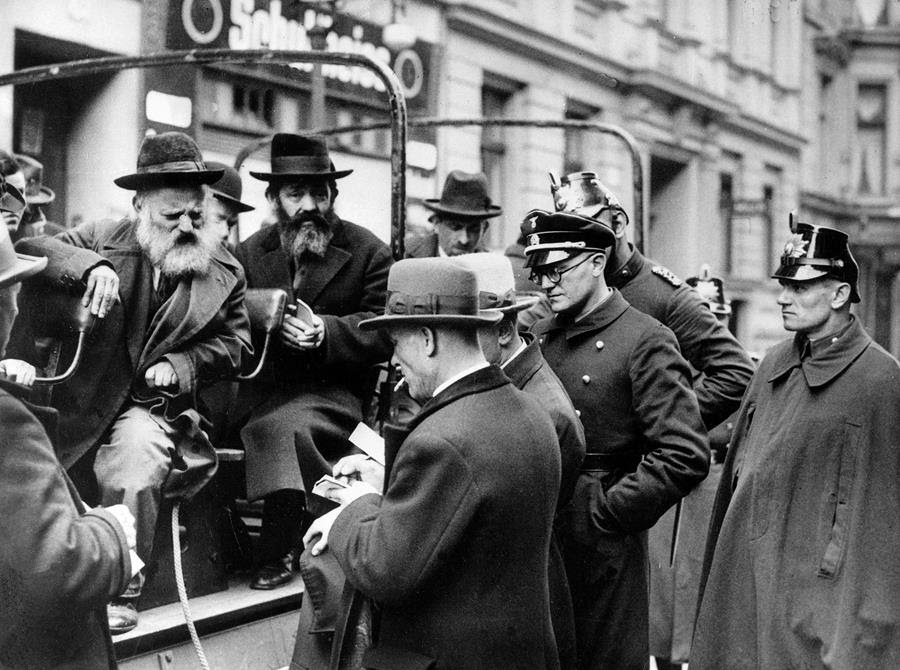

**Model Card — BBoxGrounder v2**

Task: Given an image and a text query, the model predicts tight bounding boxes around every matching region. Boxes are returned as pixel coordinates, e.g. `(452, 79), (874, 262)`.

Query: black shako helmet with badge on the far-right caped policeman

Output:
(772, 217), (859, 302)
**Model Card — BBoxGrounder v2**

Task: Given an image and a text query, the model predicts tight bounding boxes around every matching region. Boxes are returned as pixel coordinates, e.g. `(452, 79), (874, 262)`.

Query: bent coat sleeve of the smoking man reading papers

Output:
(328, 435), (479, 603)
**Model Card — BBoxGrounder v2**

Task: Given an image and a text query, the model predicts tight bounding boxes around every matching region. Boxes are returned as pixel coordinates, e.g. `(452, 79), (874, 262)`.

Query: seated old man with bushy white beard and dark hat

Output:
(4, 132), (250, 633)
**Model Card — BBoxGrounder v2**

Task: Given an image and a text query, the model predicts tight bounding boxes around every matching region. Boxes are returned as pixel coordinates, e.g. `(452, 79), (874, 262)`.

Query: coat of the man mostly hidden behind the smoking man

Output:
(503, 334), (585, 670)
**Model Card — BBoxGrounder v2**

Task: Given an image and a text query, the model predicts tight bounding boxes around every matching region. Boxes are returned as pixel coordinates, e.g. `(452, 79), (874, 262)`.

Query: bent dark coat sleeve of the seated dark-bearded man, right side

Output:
(320, 245), (394, 368)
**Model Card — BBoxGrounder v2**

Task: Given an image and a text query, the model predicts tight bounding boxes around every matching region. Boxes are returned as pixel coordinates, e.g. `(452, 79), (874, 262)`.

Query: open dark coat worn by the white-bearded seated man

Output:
(14, 219), (251, 476)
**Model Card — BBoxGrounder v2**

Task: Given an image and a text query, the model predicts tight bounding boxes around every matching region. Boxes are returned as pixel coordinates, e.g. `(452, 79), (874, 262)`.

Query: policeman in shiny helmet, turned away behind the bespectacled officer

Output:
(551, 172), (753, 428)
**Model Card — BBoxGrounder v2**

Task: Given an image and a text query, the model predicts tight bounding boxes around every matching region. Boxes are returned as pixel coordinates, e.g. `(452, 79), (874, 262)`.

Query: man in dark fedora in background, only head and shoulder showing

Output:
(406, 170), (503, 258)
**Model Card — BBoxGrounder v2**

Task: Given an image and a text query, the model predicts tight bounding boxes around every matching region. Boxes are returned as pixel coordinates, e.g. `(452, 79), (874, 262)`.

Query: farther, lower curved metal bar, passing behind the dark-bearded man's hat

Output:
(235, 117), (650, 254)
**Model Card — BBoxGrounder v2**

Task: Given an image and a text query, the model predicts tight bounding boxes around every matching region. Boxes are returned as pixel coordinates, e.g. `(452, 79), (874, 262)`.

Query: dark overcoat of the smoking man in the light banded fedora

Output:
(329, 366), (560, 670)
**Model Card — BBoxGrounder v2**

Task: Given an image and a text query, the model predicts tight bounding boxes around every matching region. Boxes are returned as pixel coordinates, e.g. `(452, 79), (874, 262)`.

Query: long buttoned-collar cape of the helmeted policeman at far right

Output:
(691, 320), (900, 670)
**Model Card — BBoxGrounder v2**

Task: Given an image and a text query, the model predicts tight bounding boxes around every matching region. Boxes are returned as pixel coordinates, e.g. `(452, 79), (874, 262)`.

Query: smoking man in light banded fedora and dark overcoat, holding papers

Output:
(305, 258), (560, 668)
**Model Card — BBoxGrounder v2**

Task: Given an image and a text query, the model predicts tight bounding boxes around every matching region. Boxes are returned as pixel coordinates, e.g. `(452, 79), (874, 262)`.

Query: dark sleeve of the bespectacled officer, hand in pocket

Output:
(597, 324), (709, 533)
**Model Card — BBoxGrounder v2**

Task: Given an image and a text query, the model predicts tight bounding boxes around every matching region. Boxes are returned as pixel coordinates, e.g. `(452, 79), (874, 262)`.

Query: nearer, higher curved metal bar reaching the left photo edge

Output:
(0, 49), (407, 259)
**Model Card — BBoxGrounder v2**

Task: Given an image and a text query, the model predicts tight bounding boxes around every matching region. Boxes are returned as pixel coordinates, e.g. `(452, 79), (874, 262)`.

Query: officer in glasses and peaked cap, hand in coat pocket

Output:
(522, 208), (709, 670)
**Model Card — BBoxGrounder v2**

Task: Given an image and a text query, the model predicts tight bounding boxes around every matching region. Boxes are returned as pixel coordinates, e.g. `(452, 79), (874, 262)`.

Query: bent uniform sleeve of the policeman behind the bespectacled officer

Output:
(665, 287), (753, 428)
